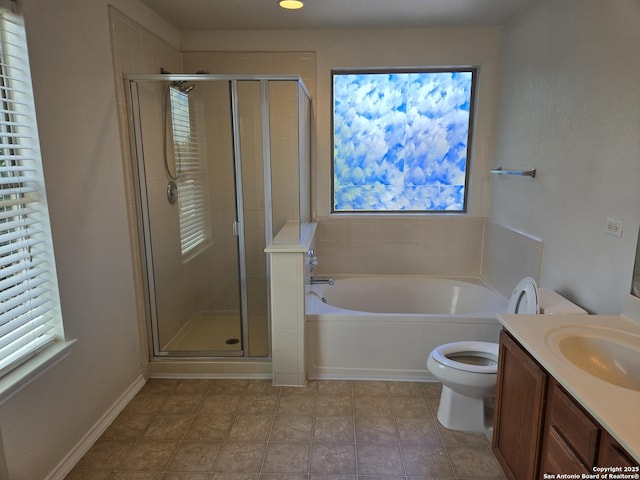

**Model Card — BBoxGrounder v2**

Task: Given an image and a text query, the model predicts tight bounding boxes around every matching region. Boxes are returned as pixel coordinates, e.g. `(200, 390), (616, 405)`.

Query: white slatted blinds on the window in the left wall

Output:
(0, 9), (64, 377)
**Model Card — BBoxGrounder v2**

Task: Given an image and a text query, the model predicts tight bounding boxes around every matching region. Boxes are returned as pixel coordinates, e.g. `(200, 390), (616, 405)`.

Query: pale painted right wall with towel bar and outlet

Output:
(491, 0), (640, 314)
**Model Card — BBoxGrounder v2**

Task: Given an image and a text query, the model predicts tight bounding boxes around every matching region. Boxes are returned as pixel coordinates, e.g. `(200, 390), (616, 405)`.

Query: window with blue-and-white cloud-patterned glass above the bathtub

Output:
(332, 69), (476, 213)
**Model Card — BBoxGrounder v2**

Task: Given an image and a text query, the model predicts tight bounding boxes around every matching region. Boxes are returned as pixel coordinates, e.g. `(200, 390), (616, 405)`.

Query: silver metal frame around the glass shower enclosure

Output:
(124, 74), (310, 361)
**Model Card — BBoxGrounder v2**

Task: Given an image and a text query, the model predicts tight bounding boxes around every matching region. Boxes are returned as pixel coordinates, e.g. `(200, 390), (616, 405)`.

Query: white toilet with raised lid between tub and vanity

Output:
(427, 277), (587, 434)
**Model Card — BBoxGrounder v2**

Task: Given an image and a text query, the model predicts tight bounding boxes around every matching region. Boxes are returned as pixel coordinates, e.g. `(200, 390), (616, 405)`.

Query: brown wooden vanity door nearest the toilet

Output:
(493, 331), (547, 480)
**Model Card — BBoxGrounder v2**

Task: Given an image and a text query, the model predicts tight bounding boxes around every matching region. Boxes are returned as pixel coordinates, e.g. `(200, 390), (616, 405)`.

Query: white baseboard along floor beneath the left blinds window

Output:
(45, 375), (146, 480)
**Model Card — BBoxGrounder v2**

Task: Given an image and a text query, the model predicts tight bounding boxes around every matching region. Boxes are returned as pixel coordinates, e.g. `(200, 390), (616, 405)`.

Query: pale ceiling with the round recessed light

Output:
(141, 0), (535, 30)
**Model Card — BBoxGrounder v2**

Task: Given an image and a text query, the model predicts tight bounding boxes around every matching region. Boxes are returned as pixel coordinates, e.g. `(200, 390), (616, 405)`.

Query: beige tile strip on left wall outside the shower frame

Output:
(109, 7), (182, 363)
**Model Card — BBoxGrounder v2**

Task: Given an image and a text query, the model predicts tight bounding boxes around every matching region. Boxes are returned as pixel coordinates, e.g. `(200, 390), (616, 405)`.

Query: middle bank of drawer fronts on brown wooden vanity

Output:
(540, 380), (600, 474)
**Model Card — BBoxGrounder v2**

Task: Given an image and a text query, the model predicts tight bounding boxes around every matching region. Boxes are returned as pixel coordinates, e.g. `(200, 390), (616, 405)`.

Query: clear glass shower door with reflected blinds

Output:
(131, 81), (244, 357)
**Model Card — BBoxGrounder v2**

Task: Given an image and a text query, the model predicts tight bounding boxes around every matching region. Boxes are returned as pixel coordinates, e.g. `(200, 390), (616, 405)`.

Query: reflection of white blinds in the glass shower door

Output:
(169, 87), (209, 258)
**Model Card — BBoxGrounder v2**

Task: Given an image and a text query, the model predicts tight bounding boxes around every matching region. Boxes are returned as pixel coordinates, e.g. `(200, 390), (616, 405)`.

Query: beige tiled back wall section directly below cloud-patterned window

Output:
(316, 216), (485, 276)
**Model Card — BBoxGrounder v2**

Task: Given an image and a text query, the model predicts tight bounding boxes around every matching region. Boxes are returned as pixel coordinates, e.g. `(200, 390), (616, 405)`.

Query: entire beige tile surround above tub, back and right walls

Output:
(316, 215), (543, 298)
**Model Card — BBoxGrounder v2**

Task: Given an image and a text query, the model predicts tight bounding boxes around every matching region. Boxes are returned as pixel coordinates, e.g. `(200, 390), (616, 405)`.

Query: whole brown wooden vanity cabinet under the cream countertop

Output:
(493, 330), (638, 480)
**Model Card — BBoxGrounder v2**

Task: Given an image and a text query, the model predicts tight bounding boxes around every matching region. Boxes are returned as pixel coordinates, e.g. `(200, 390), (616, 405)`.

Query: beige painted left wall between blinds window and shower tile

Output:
(0, 0), (178, 480)
